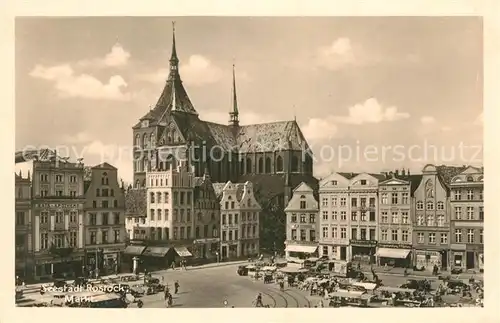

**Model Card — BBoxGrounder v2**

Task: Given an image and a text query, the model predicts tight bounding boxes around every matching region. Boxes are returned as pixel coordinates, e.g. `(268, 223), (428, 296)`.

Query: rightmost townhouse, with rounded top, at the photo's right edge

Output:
(449, 167), (484, 270)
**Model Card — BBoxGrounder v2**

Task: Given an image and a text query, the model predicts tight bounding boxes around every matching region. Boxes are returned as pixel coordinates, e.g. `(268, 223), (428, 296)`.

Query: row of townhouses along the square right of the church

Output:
(285, 165), (484, 270)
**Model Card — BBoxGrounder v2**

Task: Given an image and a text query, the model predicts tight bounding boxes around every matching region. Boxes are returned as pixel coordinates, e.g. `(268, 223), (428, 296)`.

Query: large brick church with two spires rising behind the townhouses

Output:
(132, 27), (317, 206)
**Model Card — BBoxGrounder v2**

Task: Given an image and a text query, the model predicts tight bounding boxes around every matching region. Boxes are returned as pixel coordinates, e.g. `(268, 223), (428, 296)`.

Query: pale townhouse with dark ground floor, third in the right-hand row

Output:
(347, 173), (384, 263)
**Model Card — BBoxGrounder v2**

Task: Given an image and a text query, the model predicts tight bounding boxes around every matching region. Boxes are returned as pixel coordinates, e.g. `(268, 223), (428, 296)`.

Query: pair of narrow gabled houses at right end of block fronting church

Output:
(214, 181), (261, 259)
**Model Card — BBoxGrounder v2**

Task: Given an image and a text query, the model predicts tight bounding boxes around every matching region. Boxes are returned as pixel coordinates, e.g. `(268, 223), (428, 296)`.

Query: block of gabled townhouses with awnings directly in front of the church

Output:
(124, 161), (261, 269)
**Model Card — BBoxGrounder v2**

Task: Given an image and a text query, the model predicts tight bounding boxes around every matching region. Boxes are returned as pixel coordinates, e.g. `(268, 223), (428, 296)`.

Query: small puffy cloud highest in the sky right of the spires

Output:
(317, 37), (357, 70)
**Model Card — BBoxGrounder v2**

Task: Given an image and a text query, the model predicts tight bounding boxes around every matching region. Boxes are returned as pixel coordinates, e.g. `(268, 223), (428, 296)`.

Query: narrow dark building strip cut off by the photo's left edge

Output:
(15, 172), (33, 279)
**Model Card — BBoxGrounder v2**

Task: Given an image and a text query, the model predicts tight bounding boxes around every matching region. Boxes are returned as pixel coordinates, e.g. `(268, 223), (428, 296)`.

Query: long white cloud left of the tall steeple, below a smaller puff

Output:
(30, 64), (130, 101)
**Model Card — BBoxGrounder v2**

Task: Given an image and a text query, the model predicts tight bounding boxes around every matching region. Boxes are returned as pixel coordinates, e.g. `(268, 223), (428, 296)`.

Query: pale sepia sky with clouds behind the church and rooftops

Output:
(15, 17), (483, 182)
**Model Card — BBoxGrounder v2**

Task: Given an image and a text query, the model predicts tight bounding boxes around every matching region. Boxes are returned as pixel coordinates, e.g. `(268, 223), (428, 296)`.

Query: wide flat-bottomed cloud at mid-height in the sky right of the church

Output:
(332, 98), (410, 125)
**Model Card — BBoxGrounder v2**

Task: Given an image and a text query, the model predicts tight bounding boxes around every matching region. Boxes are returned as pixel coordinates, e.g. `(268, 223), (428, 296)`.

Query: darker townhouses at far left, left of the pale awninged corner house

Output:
(15, 156), (125, 280)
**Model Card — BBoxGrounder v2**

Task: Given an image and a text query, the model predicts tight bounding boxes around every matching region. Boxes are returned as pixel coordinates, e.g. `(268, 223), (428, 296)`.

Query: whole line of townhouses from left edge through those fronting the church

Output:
(15, 156), (261, 280)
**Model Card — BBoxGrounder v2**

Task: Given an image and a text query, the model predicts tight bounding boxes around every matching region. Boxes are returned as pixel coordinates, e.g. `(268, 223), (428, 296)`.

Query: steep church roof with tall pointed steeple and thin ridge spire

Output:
(134, 22), (310, 153)
